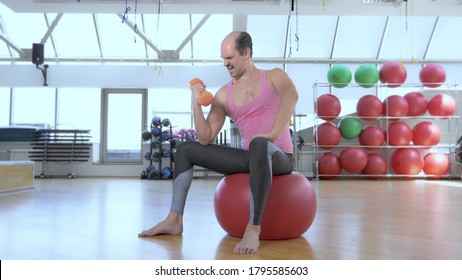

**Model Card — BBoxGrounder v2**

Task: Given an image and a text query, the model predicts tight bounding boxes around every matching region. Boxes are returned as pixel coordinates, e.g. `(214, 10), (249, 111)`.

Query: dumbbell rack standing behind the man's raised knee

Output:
(141, 117), (174, 180)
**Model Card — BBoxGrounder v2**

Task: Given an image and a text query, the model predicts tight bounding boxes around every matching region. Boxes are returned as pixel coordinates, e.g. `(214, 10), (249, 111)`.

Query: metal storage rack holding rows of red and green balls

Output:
(312, 82), (462, 179)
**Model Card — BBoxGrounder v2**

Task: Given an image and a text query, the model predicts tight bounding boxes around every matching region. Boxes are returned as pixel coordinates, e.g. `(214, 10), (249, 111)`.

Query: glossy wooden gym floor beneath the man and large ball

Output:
(0, 175), (462, 260)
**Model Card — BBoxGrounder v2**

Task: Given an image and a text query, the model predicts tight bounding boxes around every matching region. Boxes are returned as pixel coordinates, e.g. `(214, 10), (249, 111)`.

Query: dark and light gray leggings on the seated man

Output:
(170, 137), (293, 225)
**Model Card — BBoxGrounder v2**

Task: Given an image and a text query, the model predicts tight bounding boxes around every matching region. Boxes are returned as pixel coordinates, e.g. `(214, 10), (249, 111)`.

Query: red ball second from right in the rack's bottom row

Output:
(391, 148), (423, 175)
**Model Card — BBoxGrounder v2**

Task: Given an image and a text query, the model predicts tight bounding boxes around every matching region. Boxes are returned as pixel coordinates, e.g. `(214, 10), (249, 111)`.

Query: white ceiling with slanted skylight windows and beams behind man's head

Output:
(0, 0), (462, 63)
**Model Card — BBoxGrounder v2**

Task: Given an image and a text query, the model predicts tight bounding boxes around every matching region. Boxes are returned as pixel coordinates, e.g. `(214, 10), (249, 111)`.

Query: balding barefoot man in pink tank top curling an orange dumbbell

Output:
(139, 31), (298, 254)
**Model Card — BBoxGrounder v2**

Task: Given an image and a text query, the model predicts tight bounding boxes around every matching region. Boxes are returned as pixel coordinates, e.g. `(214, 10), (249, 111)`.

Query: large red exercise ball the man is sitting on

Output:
(214, 172), (317, 240)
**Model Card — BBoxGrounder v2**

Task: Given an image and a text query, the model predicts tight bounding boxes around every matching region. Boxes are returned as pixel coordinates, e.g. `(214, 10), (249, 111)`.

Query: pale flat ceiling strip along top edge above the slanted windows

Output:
(0, 0), (462, 16)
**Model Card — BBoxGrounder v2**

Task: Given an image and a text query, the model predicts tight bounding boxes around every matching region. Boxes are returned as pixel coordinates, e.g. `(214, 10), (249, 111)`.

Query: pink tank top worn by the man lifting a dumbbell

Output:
(228, 70), (293, 154)
